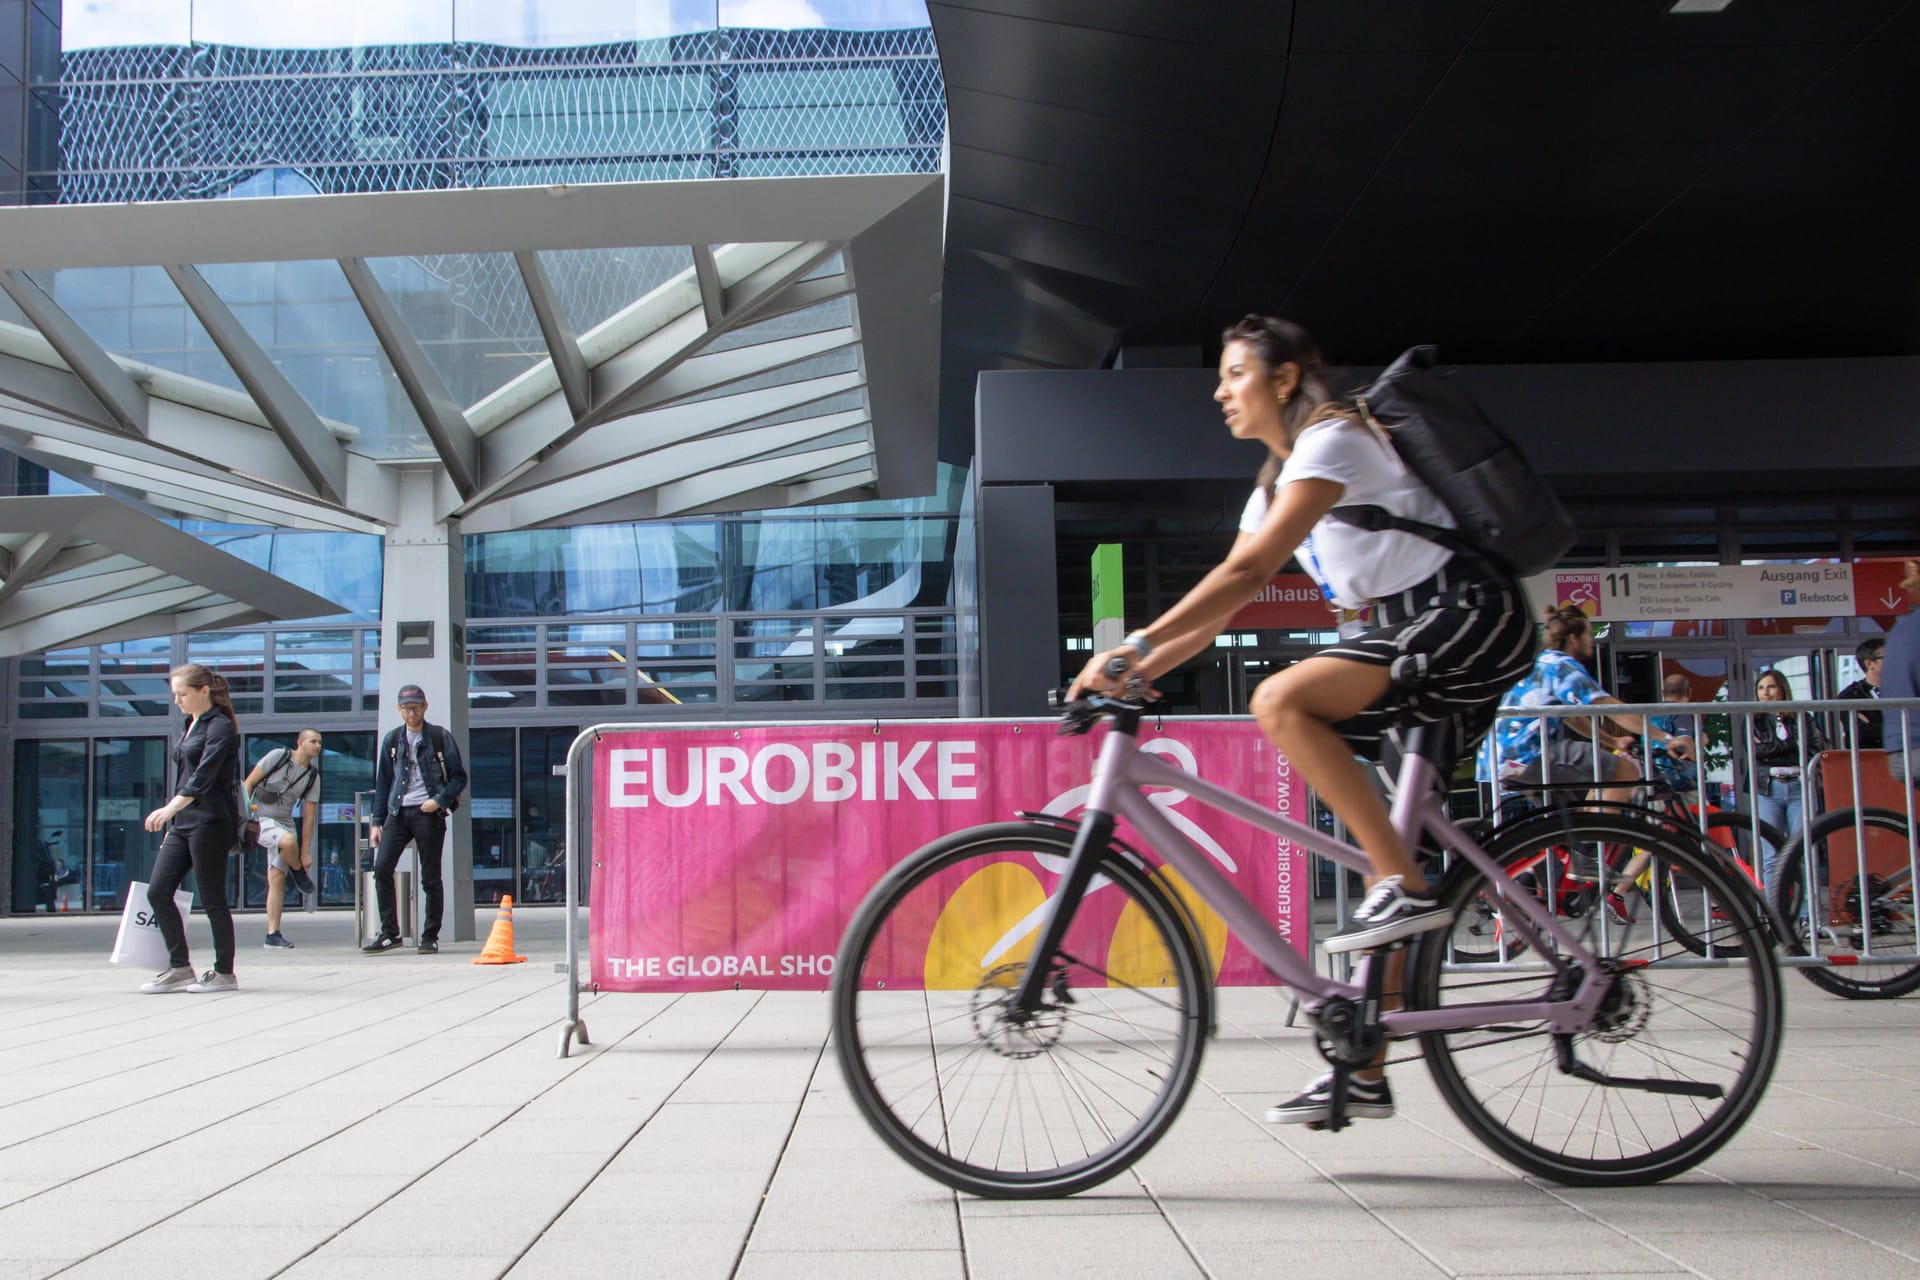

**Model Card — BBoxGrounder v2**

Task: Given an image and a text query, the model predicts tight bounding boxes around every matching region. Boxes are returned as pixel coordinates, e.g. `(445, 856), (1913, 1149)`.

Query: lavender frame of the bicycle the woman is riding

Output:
(1082, 729), (1609, 1038)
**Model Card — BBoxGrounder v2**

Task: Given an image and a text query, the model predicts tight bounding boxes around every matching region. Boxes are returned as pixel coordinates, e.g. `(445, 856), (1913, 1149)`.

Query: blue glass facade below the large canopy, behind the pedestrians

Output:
(6, 468), (975, 912)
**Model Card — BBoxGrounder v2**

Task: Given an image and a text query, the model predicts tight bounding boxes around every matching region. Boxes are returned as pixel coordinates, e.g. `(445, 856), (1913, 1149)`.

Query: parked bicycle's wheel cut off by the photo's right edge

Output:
(1768, 808), (1920, 1000)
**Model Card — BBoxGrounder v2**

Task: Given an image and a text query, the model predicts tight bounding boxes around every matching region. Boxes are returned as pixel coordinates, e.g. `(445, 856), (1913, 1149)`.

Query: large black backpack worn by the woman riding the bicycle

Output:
(1327, 347), (1574, 578)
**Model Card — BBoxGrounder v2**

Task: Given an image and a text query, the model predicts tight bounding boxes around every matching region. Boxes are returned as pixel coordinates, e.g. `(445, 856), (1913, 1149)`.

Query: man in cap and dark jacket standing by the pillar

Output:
(361, 685), (467, 956)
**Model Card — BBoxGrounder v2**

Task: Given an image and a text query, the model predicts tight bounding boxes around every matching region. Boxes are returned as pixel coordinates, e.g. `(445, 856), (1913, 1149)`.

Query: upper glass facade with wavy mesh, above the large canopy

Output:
(27, 0), (947, 203)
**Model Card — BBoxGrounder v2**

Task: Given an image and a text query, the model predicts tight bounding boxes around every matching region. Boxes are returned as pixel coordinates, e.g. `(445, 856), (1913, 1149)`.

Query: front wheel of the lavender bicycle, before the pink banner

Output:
(833, 821), (1213, 1199)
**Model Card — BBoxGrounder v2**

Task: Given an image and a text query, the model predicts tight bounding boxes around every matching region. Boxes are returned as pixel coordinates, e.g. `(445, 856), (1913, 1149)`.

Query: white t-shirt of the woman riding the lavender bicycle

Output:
(1240, 418), (1459, 608)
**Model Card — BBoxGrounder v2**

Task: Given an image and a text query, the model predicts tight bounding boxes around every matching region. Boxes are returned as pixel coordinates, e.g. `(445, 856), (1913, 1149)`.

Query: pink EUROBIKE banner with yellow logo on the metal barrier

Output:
(589, 720), (1311, 992)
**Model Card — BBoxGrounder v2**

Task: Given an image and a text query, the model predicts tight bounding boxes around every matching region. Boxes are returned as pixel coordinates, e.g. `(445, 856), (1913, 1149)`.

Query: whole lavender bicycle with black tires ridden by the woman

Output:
(833, 697), (1782, 1197)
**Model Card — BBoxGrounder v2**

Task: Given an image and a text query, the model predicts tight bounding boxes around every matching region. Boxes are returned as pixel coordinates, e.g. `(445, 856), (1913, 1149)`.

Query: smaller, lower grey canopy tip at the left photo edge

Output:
(0, 495), (340, 656)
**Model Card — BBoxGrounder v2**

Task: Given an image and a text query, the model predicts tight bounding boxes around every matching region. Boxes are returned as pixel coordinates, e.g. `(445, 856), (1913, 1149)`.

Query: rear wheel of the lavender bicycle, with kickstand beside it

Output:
(1409, 812), (1784, 1186)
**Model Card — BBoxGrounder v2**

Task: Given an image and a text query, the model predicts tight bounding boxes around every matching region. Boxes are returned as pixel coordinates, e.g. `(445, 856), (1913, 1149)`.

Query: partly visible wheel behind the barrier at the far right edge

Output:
(1770, 810), (1920, 1000)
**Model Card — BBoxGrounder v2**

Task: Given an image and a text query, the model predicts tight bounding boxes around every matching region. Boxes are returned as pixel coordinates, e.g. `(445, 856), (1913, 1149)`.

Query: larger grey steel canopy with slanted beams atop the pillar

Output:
(0, 175), (945, 533)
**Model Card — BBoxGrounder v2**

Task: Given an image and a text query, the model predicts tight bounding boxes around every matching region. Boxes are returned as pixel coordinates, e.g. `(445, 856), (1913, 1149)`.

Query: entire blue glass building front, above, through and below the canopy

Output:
(0, 0), (960, 912)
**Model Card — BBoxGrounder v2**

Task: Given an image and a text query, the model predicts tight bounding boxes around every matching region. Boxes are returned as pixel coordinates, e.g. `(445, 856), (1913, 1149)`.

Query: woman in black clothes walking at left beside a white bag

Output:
(140, 662), (240, 996)
